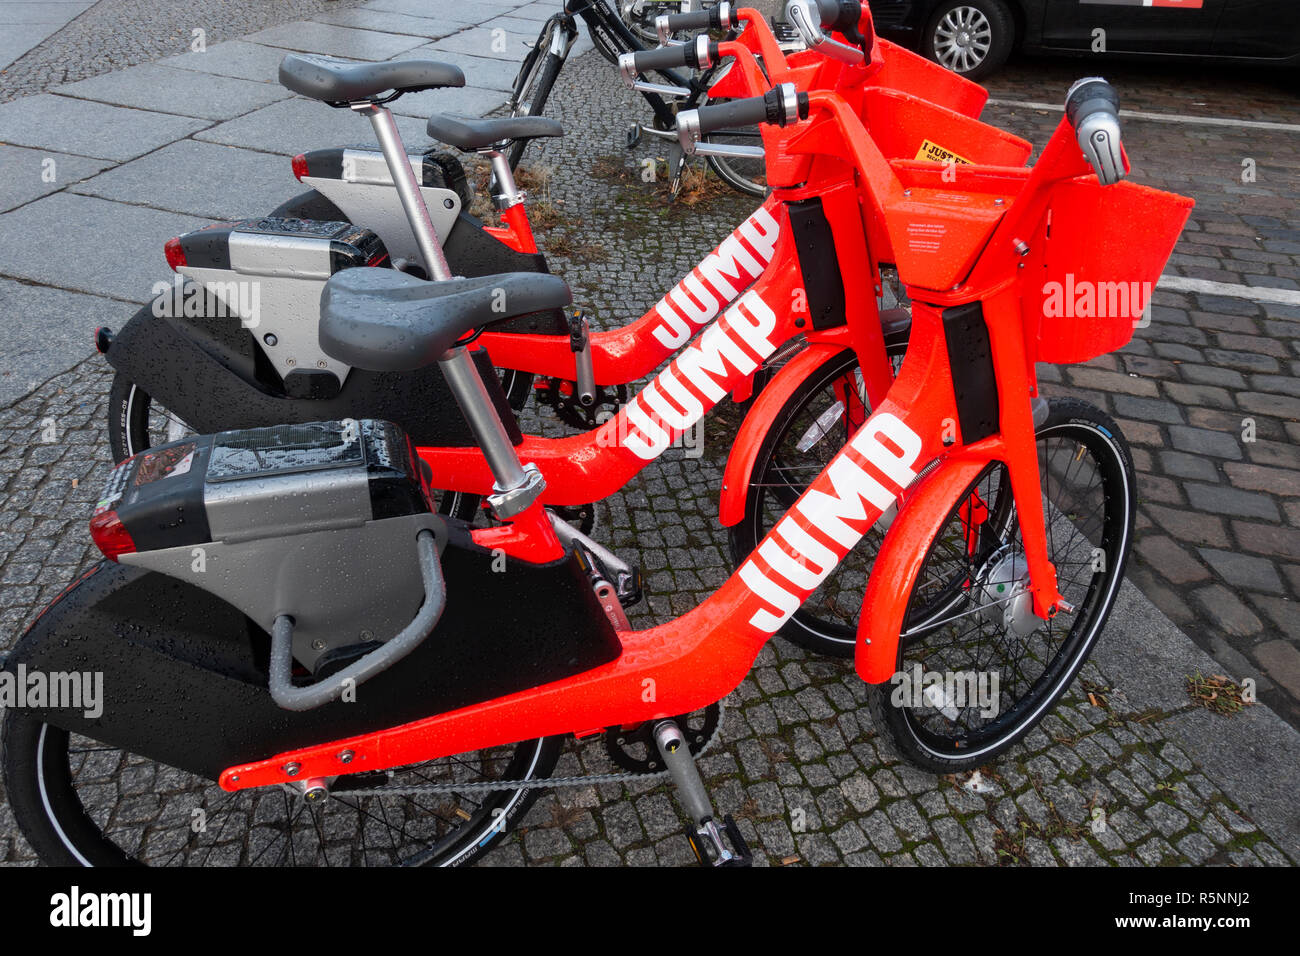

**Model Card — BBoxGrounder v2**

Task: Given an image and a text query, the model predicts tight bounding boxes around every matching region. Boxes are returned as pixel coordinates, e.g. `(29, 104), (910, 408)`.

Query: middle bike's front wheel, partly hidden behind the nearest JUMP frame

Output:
(731, 336), (907, 657)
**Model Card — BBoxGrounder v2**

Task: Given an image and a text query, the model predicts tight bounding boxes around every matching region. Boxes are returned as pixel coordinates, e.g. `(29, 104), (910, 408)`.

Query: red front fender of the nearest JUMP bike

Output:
(853, 458), (987, 684)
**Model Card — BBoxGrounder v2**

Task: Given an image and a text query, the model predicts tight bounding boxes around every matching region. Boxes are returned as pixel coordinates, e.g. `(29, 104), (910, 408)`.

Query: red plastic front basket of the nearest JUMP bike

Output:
(1021, 178), (1193, 363)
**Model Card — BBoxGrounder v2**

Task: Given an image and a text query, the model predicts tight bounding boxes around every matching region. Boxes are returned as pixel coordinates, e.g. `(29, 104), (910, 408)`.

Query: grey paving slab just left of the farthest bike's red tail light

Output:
(72, 139), (303, 220)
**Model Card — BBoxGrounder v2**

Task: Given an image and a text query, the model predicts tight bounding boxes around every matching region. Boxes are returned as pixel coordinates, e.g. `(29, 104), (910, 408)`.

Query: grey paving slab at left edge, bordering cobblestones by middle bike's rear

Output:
(0, 278), (126, 406)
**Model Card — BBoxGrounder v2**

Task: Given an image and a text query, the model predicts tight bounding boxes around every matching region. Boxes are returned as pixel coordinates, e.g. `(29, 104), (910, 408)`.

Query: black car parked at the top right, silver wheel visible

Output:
(871, 0), (1300, 79)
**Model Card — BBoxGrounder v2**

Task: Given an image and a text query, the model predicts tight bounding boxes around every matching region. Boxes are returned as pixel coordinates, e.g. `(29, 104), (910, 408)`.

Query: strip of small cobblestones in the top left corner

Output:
(0, 0), (361, 103)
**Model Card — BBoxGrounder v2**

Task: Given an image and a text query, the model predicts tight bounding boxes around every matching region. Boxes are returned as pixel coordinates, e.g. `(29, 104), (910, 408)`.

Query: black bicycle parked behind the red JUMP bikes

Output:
(507, 0), (767, 196)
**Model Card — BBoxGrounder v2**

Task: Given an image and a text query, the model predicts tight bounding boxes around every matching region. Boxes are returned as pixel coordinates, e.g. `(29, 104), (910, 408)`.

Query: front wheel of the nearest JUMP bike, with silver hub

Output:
(870, 399), (1135, 773)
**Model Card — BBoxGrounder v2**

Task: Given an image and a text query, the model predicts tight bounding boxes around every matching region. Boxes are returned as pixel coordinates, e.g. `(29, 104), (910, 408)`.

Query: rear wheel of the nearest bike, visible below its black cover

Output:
(0, 709), (562, 866)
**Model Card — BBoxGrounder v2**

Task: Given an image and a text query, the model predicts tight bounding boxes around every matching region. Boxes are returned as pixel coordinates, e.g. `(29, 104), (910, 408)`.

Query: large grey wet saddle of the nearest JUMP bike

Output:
(320, 269), (573, 372)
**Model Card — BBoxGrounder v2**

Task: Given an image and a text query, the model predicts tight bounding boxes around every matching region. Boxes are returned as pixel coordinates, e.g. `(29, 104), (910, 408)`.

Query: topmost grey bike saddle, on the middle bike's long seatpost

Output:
(280, 53), (465, 105)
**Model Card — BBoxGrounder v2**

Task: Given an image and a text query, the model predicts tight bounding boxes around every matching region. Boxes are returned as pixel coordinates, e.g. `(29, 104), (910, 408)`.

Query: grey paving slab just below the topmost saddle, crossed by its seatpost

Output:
(195, 96), (428, 156)
